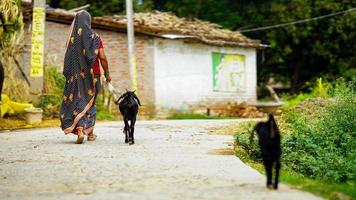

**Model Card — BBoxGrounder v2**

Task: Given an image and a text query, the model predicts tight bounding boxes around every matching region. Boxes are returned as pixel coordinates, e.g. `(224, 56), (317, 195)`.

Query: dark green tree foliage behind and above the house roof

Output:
(49, 0), (356, 91)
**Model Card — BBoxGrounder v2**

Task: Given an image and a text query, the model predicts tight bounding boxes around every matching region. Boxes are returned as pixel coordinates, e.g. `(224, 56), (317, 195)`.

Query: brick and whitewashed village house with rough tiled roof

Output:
(20, 2), (262, 117)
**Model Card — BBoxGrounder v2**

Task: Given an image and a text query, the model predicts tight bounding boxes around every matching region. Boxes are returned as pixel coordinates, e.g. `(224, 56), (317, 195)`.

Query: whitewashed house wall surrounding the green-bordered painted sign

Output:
(154, 38), (257, 110)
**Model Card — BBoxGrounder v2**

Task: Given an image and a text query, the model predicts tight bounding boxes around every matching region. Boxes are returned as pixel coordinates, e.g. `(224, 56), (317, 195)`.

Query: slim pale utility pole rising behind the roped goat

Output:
(126, 0), (138, 92)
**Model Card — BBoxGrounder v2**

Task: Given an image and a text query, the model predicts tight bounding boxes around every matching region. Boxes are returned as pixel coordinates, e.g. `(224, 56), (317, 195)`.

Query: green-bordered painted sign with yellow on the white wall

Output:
(212, 52), (246, 92)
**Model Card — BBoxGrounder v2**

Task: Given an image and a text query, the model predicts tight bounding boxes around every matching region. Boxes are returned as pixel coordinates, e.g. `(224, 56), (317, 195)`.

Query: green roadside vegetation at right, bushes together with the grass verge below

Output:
(235, 78), (356, 199)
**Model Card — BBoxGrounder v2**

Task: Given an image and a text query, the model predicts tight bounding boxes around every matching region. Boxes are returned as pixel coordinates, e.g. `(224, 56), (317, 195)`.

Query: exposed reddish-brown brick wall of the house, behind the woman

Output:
(20, 21), (154, 116)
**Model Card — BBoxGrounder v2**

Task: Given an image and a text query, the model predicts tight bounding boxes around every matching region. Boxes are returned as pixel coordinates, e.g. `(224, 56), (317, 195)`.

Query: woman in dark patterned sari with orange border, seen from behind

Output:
(60, 11), (111, 144)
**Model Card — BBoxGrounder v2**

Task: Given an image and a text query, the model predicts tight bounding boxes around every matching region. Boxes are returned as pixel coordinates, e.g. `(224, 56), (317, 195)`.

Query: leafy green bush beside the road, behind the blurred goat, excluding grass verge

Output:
(236, 79), (356, 182)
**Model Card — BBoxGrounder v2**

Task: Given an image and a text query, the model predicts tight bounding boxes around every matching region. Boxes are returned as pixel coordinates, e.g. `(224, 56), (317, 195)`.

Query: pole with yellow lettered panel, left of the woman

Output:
(30, 0), (46, 102)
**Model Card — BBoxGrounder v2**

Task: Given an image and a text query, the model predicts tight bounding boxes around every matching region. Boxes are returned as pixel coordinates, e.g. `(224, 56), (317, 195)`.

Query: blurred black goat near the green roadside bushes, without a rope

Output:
(251, 113), (282, 189)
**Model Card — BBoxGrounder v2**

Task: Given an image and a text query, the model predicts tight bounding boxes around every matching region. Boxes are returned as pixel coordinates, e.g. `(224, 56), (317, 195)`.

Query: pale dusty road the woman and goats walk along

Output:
(0, 120), (317, 200)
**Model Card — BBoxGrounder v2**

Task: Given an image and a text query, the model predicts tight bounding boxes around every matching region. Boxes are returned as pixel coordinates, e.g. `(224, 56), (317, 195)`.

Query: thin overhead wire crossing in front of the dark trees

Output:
(237, 8), (356, 33)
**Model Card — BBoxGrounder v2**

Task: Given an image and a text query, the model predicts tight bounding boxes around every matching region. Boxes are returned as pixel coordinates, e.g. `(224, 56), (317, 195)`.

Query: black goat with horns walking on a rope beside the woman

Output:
(115, 91), (141, 145)
